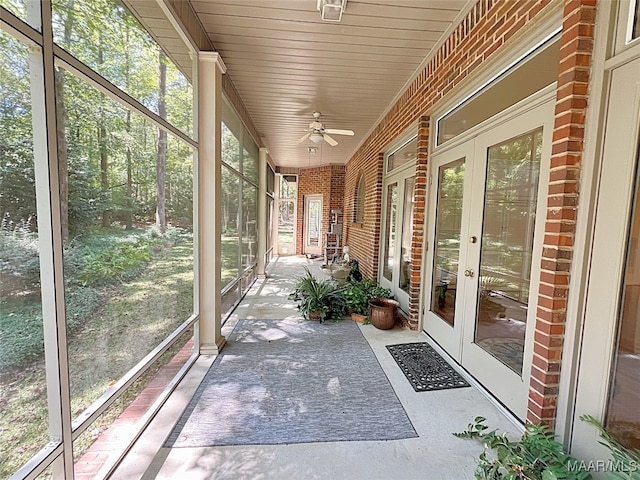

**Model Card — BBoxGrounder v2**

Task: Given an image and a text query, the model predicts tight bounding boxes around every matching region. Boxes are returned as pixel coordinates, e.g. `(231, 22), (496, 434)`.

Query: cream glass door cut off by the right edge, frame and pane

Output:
(571, 58), (640, 459)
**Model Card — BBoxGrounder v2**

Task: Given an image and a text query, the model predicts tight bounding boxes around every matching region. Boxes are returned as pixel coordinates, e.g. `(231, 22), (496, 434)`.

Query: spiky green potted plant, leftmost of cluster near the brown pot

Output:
(288, 268), (345, 323)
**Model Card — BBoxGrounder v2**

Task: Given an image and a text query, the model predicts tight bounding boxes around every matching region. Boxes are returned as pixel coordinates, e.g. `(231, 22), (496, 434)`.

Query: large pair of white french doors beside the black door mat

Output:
(423, 97), (553, 420)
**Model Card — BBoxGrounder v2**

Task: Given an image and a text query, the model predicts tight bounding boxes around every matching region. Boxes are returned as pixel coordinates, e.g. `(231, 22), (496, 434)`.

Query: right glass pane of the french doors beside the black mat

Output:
(475, 129), (542, 373)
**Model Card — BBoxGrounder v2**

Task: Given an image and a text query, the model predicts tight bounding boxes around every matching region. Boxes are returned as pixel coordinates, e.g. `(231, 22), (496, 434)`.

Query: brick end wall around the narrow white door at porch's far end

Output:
(296, 165), (345, 254)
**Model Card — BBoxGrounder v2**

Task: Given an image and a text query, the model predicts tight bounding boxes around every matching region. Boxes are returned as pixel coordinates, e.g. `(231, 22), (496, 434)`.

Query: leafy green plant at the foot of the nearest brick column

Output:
(454, 417), (592, 480)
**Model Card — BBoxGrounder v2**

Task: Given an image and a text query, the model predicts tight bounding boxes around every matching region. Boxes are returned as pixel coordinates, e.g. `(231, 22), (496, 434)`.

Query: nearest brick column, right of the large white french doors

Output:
(527, 0), (596, 428)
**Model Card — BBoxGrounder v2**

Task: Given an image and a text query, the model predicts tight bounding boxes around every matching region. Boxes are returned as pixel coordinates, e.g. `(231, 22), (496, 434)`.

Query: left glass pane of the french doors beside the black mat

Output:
(431, 158), (465, 325)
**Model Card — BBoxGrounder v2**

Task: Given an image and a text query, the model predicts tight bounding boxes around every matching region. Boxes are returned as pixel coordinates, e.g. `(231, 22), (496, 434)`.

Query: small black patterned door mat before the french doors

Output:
(387, 342), (469, 392)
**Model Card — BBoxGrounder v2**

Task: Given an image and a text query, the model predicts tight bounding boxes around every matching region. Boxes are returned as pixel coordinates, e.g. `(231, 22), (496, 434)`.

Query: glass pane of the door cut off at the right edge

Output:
(605, 142), (640, 449)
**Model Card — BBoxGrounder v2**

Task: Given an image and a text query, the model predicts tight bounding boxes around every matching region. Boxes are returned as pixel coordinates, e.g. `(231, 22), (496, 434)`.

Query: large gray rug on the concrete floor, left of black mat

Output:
(165, 319), (417, 447)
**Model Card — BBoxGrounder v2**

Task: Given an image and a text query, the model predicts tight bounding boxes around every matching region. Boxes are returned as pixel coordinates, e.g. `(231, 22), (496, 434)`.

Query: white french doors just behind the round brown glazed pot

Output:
(379, 166), (416, 311)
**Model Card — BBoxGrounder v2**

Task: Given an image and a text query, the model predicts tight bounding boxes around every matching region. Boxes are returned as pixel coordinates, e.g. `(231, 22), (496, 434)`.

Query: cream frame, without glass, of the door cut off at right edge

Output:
(571, 58), (640, 459)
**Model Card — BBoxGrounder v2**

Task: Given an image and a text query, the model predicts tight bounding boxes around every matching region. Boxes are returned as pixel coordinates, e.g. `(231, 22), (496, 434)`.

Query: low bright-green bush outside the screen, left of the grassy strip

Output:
(78, 240), (151, 285)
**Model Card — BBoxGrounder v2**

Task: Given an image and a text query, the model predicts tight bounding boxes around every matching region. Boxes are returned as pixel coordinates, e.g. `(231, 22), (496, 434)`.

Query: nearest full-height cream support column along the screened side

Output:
(198, 52), (226, 355)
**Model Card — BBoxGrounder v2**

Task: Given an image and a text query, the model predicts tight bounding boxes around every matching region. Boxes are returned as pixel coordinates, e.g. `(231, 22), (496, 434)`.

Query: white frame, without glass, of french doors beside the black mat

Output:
(422, 93), (555, 421)
